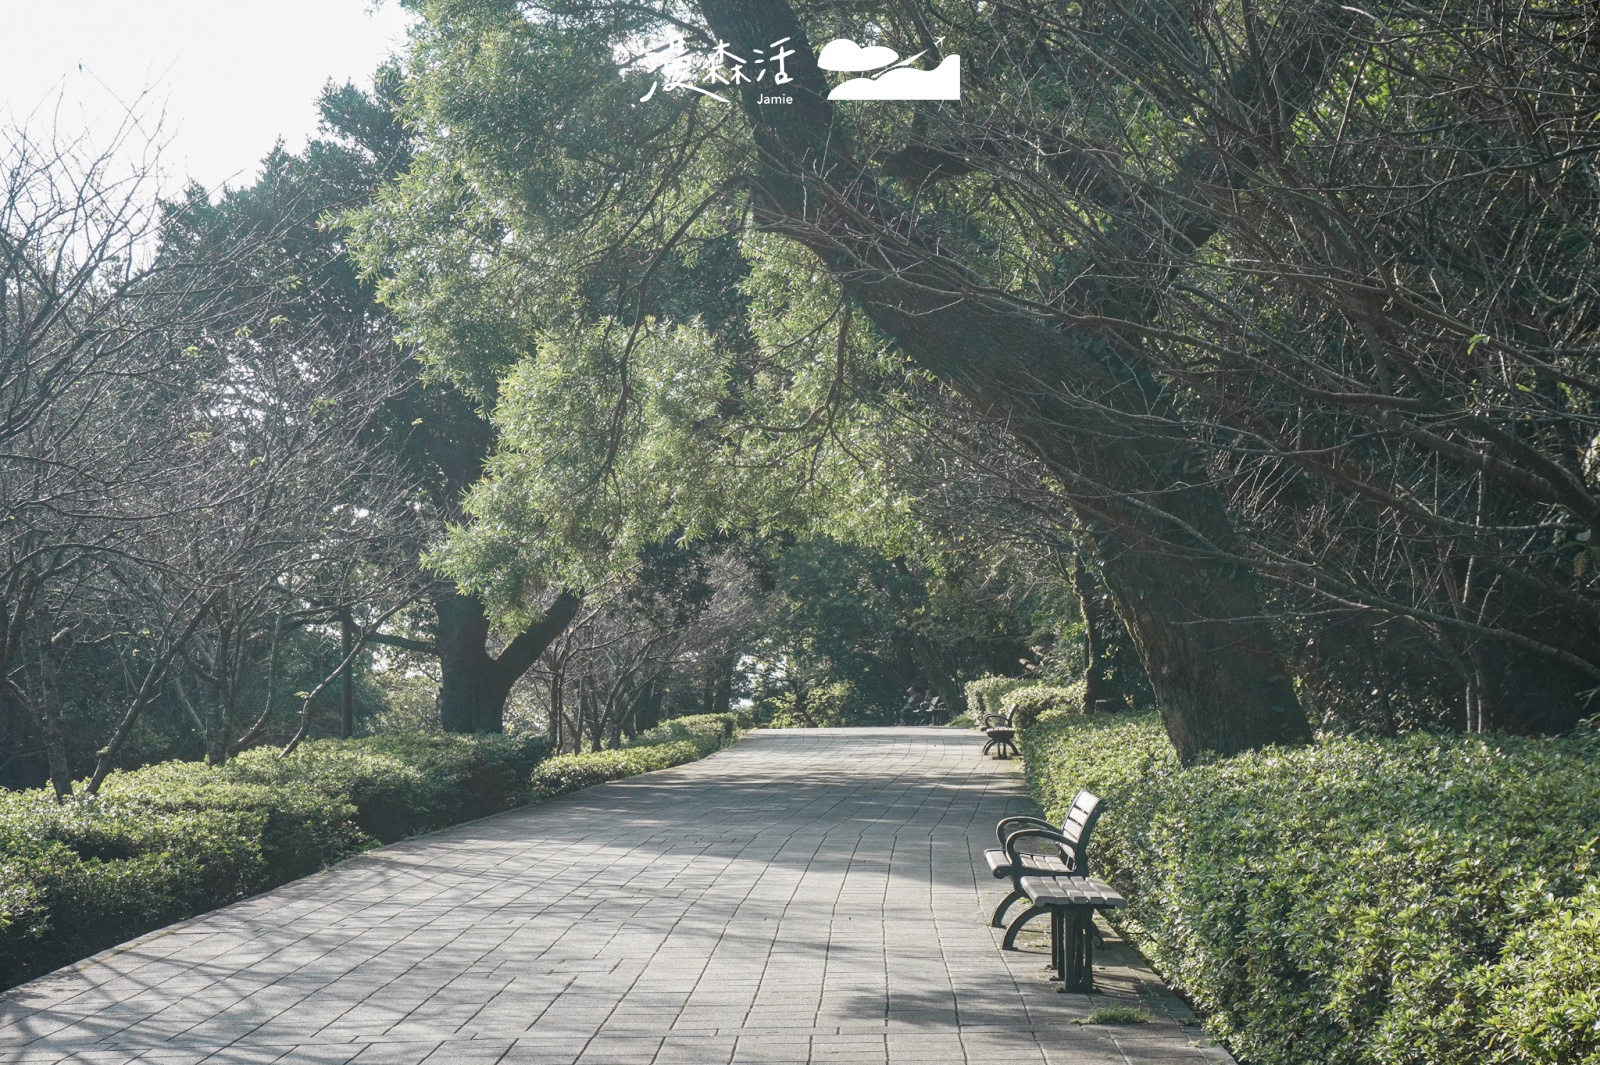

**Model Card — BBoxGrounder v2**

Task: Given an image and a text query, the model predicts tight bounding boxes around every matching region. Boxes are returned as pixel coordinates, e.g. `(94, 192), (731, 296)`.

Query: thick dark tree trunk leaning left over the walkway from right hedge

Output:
(701, 0), (1310, 761)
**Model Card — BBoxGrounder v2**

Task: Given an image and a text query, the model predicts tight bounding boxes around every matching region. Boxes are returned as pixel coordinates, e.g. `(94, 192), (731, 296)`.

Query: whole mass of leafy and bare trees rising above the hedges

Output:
(0, 0), (1600, 787)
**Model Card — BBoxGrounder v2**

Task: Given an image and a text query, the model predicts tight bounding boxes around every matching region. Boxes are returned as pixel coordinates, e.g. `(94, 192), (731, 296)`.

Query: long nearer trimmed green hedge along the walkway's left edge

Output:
(0, 736), (549, 987)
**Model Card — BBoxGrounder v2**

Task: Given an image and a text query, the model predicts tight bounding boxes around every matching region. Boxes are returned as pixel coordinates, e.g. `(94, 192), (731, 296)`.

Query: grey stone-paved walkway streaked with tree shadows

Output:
(0, 728), (1230, 1065)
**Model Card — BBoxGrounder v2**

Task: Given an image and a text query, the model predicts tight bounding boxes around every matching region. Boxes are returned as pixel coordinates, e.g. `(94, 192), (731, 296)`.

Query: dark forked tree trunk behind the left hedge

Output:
(434, 590), (578, 732)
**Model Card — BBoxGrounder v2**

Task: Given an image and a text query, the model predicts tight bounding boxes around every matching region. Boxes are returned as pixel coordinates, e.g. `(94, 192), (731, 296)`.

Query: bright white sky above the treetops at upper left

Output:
(0, 0), (406, 193)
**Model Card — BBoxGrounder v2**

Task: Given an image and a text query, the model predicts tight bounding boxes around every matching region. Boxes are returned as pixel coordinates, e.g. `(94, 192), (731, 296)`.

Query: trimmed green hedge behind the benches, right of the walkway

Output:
(1022, 703), (1600, 1065)
